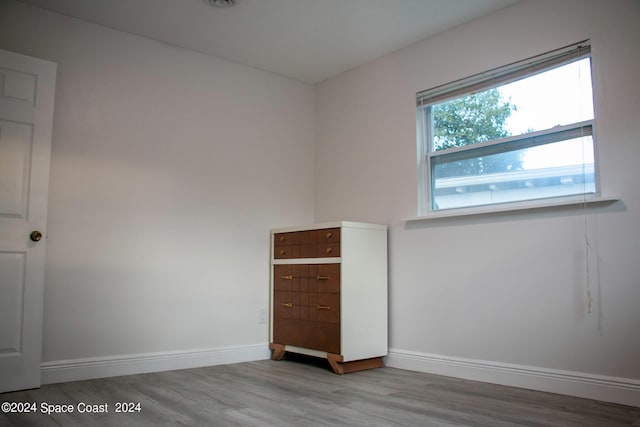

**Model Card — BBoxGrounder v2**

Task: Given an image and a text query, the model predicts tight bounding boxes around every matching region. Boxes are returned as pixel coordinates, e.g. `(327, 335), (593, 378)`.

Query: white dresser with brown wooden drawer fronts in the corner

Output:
(270, 222), (388, 374)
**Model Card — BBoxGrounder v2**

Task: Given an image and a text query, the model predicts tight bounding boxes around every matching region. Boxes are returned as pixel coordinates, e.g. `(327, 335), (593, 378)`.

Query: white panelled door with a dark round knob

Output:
(0, 50), (56, 392)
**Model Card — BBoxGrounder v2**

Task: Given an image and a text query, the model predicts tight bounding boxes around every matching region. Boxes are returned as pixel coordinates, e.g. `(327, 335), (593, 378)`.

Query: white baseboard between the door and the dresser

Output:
(41, 343), (271, 384)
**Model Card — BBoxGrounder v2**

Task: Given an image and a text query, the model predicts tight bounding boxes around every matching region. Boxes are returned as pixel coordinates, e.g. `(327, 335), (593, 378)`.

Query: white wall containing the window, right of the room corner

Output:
(315, 0), (640, 405)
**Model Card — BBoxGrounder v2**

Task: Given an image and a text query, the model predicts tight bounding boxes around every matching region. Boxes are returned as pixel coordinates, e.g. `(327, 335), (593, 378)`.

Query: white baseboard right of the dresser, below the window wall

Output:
(386, 349), (640, 407)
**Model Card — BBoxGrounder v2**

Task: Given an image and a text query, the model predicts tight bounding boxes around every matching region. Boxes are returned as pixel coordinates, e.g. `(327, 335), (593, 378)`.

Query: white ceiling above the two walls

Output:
(21, 0), (518, 83)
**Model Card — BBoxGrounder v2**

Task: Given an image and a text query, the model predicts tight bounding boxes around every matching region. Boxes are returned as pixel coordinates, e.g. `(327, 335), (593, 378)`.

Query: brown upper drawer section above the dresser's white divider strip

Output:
(273, 228), (340, 259)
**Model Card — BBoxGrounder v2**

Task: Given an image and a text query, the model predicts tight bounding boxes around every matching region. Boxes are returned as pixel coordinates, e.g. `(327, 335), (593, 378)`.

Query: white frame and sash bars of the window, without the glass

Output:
(416, 40), (601, 217)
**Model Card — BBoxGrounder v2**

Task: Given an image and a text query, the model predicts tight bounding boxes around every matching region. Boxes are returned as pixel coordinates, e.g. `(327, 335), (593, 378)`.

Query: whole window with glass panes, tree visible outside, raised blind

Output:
(417, 41), (598, 215)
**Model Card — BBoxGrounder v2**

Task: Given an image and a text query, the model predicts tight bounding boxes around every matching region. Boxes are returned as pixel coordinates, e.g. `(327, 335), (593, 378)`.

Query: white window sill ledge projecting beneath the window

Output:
(404, 195), (620, 222)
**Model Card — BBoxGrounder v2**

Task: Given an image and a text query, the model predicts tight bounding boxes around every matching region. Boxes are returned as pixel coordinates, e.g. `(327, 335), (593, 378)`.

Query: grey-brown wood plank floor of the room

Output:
(0, 358), (640, 427)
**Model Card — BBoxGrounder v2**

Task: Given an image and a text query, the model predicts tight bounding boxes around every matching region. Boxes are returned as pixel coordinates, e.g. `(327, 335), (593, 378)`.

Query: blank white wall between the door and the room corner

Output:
(0, 0), (314, 368)
